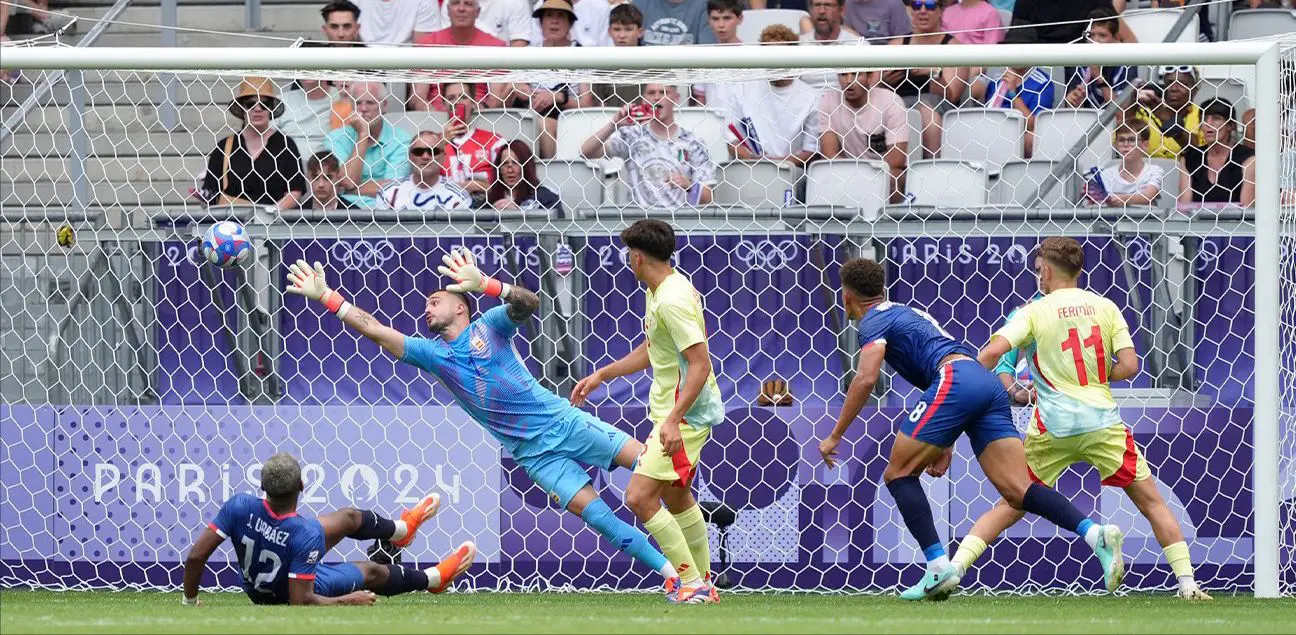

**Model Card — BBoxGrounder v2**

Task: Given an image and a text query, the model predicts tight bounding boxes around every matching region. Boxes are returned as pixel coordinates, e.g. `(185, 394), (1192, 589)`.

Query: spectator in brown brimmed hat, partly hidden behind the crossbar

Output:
(512, 0), (594, 158)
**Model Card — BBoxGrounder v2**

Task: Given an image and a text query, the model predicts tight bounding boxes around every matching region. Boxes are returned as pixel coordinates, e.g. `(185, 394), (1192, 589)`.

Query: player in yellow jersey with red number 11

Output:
(937, 237), (1210, 600)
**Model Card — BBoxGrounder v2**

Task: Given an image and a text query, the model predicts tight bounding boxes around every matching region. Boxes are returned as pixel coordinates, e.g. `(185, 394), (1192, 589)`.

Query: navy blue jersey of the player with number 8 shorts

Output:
(858, 302), (976, 390)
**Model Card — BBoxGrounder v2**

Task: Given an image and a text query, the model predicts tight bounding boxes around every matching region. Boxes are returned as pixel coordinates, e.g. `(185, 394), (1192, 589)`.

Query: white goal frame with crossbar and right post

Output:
(0, 41), (1282, 597)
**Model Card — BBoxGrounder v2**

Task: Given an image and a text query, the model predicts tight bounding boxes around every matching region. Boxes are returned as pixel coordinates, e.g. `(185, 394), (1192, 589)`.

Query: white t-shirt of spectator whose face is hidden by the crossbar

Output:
(724, 79), (820, 157)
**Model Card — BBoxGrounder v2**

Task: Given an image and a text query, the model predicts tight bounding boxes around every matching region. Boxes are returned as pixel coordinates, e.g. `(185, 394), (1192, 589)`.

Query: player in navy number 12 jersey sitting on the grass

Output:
(184, 452), (477, 605)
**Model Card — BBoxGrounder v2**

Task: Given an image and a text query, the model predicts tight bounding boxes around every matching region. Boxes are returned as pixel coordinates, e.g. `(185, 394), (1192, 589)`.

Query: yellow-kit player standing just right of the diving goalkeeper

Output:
(572, 219), (724, 604)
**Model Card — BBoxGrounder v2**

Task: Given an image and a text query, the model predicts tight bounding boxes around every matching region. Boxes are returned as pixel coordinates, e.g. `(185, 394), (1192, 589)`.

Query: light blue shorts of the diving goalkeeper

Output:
(511, 411), (630, 508)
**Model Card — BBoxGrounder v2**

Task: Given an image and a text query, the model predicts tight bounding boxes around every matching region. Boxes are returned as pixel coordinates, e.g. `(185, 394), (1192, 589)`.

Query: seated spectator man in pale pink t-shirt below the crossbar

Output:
(818, 71), (908, 202)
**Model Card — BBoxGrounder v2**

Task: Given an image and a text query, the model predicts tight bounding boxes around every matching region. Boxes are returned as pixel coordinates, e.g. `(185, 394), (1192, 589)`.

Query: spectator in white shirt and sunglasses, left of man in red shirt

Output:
(378, 130), (473, 211)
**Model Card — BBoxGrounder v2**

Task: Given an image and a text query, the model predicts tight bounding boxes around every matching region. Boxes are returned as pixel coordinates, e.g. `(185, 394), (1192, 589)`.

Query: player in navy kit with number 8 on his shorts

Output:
(819, 258), (1124, 600)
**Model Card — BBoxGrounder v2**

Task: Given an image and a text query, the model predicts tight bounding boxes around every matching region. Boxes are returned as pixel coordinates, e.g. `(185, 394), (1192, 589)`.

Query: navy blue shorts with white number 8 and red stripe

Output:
(899, 359), (1021, 455)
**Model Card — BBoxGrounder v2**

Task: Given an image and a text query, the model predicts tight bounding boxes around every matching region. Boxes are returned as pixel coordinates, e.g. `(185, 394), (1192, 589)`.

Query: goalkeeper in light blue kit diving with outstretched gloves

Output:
(288, 250), (679, 600)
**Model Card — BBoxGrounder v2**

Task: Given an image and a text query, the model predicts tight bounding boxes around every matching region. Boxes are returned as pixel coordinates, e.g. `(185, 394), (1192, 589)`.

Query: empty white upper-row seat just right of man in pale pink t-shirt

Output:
(941, 108), (1021, 172)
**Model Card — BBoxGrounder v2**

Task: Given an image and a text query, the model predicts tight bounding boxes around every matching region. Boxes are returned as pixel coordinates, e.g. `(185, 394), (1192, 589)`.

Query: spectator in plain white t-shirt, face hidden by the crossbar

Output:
(726, 25), (819, 167)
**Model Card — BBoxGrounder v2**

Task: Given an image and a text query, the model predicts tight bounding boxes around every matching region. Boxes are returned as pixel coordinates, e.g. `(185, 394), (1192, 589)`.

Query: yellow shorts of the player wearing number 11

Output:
(1026, 424), (1152, 487)
